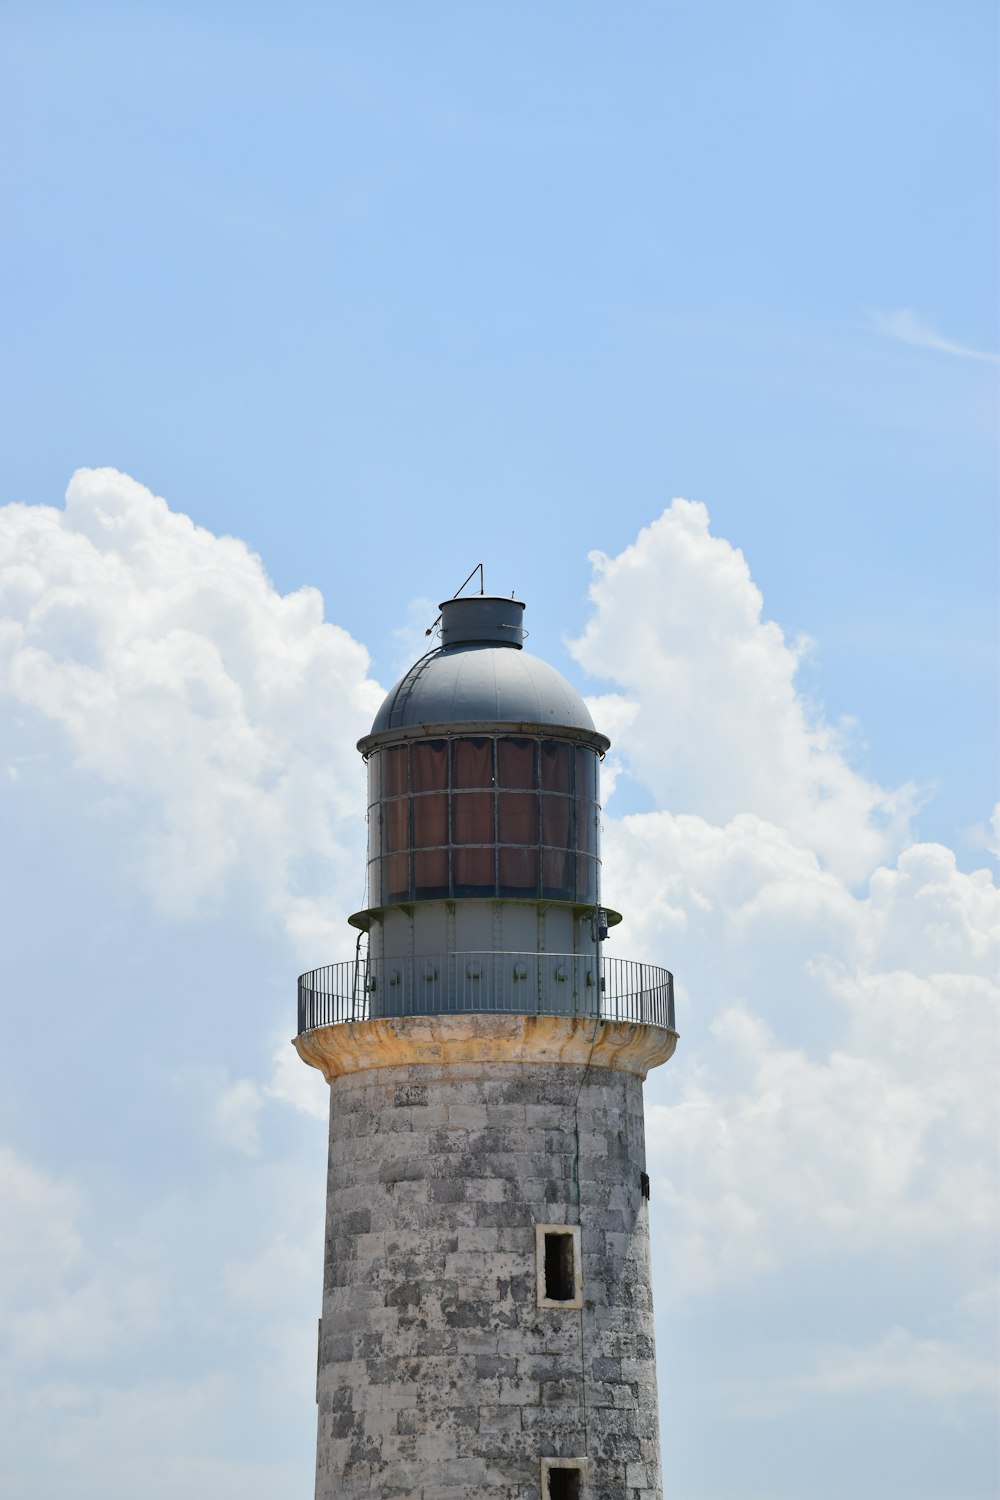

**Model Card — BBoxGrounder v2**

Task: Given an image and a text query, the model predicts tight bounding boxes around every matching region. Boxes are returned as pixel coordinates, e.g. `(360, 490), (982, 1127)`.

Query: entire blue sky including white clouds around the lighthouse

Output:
(0, 0), (1000, 1500)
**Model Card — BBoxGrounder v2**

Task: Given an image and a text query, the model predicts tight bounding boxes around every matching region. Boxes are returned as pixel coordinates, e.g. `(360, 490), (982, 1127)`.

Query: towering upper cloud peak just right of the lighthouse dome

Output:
(571, 500), (915, 881)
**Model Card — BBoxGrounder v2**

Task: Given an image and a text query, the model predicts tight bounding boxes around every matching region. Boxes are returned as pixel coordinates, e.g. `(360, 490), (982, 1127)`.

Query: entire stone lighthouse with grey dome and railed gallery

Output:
(295, 596), (678, 1500)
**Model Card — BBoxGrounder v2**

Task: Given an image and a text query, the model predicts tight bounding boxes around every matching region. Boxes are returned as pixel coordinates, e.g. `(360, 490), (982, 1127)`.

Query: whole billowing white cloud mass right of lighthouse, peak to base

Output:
(573, 513), (1000, 1428)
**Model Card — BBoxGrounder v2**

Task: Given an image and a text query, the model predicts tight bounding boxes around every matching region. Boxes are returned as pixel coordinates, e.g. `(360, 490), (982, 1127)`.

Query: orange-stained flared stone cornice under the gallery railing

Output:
(292, 1014), (678, 1083)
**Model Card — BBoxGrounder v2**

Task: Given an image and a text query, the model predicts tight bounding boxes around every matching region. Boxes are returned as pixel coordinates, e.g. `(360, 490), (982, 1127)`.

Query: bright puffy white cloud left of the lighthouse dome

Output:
(0, 468), (381, 956)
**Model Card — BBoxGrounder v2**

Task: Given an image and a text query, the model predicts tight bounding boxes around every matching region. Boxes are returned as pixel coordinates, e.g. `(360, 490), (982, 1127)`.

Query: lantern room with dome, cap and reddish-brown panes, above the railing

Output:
(351, 596), (618, 987)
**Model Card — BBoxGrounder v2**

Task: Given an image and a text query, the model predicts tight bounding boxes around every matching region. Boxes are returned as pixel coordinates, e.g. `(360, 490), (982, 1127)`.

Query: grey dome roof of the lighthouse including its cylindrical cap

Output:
(358, 596), (609, 750)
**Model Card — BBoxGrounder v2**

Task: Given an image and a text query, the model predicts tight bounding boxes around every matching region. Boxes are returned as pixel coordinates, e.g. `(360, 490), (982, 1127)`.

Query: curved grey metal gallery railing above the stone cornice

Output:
(298, 951), (675, 1035)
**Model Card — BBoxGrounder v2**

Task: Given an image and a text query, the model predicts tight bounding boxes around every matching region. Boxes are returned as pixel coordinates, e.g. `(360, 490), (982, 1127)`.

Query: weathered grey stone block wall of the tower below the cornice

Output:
(316, 1062), (661, 1500)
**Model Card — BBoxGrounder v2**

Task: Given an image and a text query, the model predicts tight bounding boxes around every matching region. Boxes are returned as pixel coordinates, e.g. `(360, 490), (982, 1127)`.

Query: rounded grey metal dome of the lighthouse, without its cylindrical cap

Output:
(372, 644), (597, 735)
